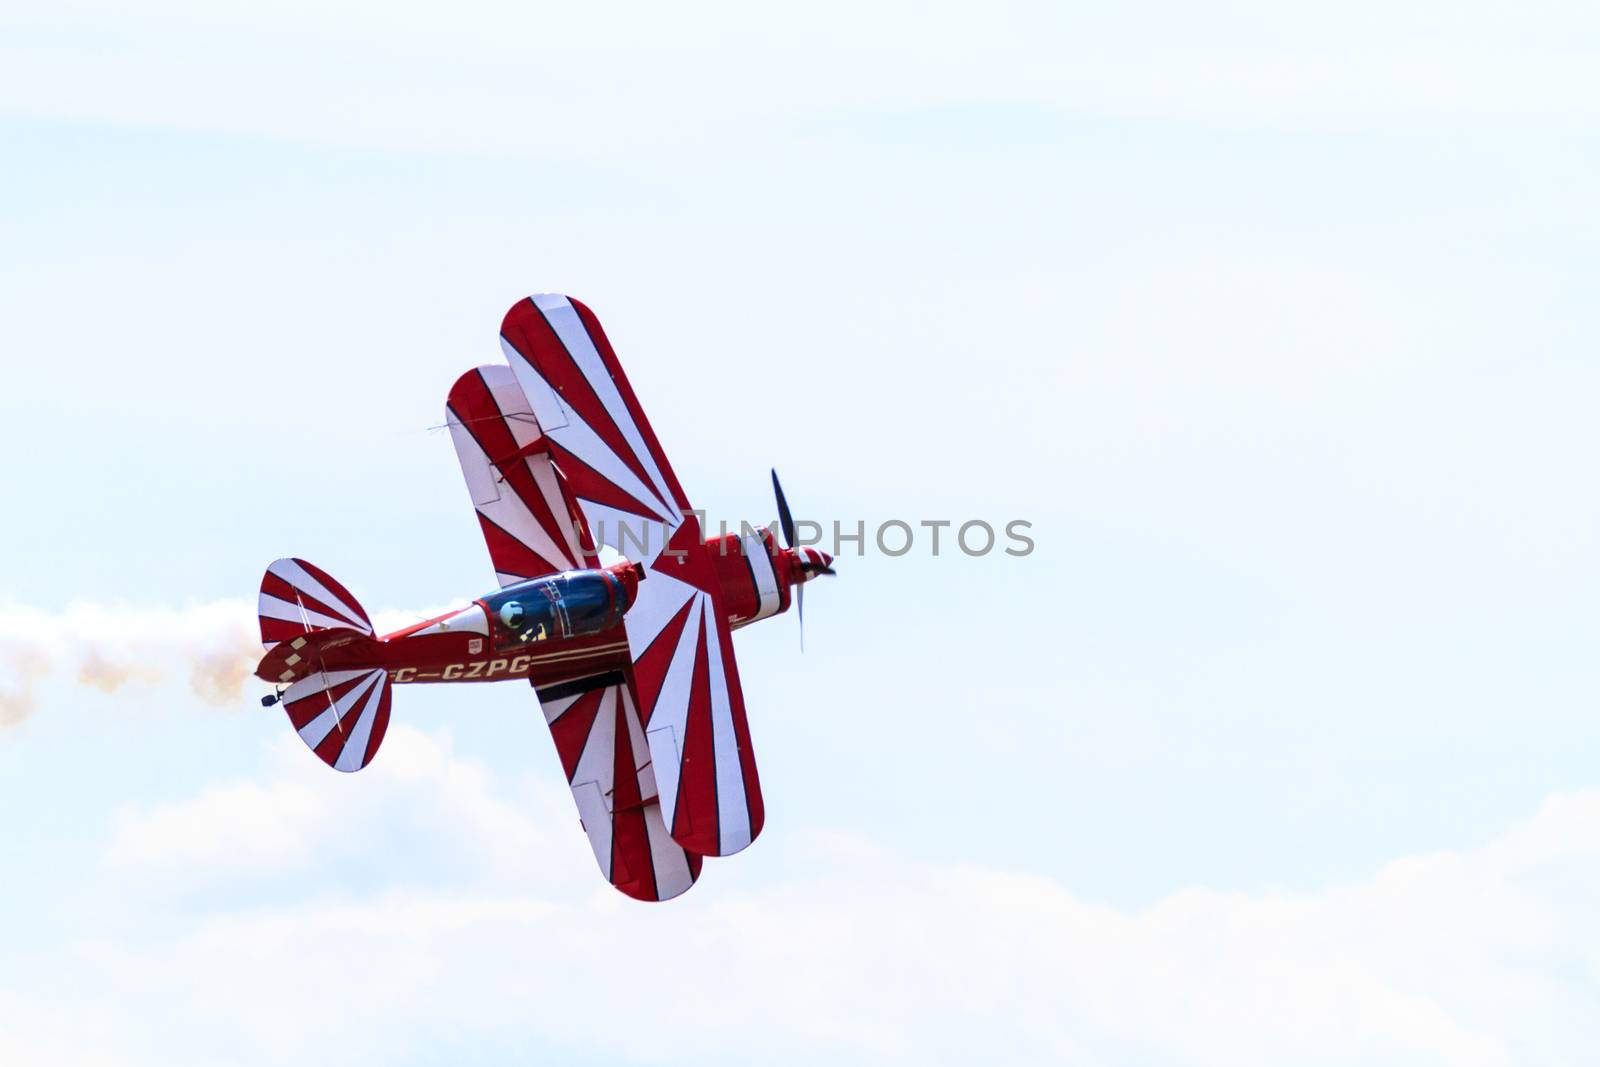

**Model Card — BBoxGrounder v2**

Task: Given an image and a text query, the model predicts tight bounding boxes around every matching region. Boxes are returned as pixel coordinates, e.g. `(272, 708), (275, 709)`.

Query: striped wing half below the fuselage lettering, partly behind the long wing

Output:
(539, 673), (701, 901)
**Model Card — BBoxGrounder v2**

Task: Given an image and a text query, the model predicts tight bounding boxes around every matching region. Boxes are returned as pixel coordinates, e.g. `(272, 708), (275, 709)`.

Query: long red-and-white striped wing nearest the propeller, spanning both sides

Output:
(501, 294), (765, 856)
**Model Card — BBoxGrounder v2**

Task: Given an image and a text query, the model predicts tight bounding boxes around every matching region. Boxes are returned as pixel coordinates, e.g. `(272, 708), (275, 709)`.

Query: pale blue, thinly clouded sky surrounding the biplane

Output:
(0, 0), (1600, 1065)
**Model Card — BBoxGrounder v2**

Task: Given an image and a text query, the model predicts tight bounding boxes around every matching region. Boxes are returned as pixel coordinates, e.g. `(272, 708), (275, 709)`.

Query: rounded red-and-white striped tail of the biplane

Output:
(256, 560), (390, 771)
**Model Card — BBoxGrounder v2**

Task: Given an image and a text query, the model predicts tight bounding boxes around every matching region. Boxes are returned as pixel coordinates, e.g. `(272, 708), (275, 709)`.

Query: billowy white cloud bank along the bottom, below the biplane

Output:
(0, 728), (1600, 1064)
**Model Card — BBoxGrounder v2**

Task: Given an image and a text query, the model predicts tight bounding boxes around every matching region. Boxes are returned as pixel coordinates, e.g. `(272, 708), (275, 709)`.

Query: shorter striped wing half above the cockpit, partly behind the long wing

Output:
(445, 366), (597, 587)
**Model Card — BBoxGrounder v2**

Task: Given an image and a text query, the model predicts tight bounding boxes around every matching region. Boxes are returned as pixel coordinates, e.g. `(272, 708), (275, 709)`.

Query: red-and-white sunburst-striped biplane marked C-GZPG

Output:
(256, 294), (834, 901)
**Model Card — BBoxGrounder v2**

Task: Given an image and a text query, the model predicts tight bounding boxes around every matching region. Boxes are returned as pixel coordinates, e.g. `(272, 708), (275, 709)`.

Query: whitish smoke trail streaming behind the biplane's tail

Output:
(0, 600), (440, 728)
